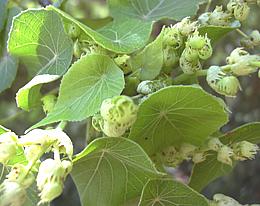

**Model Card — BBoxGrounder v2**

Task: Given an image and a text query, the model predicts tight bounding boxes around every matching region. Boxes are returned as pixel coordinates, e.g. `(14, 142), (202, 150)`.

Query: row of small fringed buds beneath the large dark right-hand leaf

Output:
(158, 137), (259, 167)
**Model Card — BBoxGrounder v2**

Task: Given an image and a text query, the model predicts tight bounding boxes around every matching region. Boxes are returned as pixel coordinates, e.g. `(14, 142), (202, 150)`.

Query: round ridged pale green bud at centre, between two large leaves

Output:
(100, 96), (138, 126)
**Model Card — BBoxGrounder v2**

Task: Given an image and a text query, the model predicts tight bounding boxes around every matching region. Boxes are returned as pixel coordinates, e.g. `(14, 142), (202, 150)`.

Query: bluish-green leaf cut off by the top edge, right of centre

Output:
(109, 0), (205, 22)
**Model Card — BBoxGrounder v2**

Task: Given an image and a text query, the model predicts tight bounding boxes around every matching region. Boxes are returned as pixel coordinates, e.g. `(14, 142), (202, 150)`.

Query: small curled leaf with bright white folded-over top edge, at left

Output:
(16, 74), (60, 111)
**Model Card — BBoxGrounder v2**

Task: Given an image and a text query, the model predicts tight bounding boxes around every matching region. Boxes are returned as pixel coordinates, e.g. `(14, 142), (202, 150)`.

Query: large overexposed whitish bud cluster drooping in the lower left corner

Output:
(0, 129), (73, 206)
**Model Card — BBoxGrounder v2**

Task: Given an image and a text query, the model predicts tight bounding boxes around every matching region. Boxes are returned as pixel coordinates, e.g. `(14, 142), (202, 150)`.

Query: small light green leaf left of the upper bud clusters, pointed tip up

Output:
(130, 32), (163, 80)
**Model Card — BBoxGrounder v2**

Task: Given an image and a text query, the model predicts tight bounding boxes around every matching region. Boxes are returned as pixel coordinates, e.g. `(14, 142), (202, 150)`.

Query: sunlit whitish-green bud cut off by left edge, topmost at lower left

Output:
(0, 132), (18, 164)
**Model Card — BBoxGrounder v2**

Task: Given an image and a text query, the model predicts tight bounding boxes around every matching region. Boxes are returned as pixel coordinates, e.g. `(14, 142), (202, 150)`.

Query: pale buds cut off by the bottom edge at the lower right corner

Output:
(209, 194), (260, 206)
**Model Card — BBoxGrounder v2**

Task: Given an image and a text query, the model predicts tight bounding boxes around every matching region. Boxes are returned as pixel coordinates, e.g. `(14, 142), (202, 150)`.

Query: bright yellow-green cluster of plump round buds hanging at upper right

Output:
(180, 31), (212, 74)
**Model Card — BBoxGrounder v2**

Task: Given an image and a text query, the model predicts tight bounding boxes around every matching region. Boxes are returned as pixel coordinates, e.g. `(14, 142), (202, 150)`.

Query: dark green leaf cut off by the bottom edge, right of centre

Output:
(138, 179), (209, 206)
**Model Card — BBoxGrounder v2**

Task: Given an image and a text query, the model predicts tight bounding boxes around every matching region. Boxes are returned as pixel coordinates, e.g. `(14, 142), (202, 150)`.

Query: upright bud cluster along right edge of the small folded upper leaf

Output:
(162, 17), (198, 68)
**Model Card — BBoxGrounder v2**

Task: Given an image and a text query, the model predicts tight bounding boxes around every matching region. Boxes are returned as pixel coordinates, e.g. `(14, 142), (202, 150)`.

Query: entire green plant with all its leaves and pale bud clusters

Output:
(0, 0), (260, 206)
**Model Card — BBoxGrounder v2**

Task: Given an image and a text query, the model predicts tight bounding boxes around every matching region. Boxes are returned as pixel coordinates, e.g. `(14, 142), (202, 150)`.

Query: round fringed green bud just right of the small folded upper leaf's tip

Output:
(162, 27), (183, 49)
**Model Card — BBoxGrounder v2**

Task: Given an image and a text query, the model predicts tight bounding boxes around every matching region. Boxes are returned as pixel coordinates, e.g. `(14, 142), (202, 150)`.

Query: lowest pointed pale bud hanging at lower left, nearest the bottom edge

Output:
(39, 182), (63, 204)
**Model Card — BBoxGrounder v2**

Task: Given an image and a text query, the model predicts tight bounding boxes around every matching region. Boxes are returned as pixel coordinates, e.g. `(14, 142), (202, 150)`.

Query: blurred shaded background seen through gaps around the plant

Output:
(0, 0), (260, 206)
